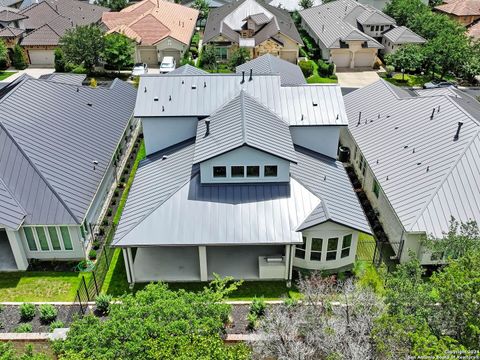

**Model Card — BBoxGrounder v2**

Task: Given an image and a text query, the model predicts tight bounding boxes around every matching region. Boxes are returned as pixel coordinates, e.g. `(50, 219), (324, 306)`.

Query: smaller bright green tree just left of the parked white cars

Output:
(102, 33), (135, 71)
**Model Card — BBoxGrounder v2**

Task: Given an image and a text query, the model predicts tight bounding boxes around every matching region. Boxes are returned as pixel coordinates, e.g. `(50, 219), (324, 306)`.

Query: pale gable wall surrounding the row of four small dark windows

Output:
(200, 146), (290, 183)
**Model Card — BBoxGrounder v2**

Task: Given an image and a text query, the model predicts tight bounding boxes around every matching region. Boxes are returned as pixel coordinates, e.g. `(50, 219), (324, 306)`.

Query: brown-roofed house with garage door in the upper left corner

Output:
(17, 0), (109, 66)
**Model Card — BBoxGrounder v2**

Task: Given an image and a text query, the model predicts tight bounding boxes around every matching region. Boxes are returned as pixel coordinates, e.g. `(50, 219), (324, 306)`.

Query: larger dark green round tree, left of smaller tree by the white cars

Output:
(60, 25), (105, 71)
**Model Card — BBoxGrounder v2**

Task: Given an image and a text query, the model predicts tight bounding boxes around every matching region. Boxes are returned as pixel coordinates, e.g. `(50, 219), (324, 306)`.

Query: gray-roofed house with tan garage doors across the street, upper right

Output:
(300, 0), (423, 69)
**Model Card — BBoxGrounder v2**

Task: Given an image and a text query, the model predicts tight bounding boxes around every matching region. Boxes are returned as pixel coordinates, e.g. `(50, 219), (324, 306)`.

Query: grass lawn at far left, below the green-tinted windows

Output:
(0, 271), (81, 302)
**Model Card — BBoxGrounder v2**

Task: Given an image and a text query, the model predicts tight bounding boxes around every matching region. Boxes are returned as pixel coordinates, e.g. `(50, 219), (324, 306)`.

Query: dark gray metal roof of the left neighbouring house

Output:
(0, 78), (136, 225)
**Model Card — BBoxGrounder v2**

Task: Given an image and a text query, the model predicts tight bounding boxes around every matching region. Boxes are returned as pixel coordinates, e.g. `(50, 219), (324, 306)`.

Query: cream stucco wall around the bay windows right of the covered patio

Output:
(293, 222), (358, 270)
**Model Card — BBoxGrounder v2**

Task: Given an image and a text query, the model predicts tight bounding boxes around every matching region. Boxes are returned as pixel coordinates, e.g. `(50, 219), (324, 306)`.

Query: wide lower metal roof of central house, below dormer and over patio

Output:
(113, 142), (370, 246)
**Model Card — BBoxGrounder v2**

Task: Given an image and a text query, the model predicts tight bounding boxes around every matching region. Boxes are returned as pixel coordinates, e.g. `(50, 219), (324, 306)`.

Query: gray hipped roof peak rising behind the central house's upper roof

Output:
(236, 54), (307, 86)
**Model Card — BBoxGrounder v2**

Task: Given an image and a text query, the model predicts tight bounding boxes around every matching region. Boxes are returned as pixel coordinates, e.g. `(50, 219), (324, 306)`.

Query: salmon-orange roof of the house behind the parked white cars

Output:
(102, 0), (199, 45)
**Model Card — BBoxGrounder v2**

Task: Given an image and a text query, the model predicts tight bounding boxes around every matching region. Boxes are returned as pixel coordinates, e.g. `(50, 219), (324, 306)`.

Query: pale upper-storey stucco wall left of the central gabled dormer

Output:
(142, 117), (198, 155)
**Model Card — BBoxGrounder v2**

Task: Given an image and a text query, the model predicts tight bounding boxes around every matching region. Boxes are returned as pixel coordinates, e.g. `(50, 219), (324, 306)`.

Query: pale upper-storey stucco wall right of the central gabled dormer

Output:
(290, 126), (341, 159)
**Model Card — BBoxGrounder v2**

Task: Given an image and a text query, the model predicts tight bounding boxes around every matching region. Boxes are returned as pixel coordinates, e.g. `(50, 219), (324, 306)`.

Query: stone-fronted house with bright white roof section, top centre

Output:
(203, 0), (303, 64)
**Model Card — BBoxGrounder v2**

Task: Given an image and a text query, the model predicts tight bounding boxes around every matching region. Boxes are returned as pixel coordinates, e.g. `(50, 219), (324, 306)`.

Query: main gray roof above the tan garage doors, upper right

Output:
(300, 0), (383, 49)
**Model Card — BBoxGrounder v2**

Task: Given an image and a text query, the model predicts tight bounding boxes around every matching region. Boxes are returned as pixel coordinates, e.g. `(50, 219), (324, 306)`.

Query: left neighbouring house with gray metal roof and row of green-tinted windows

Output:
(0, 74), (136, 271)
